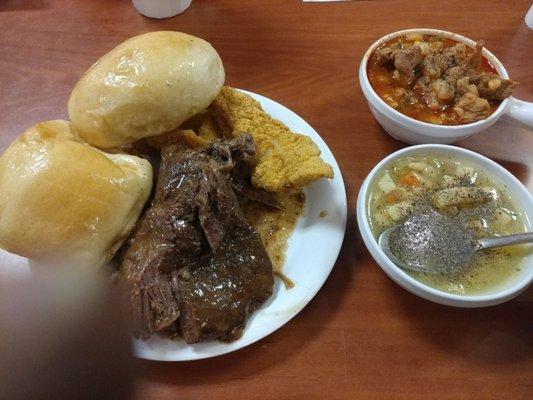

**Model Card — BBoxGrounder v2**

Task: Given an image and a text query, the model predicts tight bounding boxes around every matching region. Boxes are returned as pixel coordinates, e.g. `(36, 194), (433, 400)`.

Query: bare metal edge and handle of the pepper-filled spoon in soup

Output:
(378, 225), (533, 274)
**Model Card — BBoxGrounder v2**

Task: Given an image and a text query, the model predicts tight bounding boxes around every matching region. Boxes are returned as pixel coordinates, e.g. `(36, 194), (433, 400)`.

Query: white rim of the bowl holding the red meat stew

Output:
(359, 28), (509, 136)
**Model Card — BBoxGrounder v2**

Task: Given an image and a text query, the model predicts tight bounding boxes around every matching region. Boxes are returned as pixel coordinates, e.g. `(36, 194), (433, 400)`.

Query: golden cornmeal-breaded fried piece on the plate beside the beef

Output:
(209, 86), (333, 193)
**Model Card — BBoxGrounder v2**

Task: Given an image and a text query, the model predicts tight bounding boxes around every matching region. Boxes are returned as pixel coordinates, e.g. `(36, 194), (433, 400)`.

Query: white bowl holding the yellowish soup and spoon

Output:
(357, 144), (533, 307)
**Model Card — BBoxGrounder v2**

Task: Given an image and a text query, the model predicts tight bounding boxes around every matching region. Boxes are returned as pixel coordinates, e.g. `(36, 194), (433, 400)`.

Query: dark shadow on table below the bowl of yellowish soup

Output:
(390, 281), (533, 365)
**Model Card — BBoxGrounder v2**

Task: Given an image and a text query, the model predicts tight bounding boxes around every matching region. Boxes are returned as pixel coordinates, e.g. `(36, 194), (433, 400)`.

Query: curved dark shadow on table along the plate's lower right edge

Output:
(132, 218), (359, 386)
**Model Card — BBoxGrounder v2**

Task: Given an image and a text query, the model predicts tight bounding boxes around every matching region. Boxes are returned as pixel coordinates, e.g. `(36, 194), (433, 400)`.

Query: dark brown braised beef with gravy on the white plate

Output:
(122, 135), (273, 343)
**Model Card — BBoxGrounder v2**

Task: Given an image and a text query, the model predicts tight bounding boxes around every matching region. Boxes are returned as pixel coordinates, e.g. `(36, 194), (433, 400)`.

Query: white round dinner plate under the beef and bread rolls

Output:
(0, 90), (347, 361)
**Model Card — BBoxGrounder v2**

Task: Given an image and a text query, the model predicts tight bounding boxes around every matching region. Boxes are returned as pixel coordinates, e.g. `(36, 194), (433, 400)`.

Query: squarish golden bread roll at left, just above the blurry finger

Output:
(0, 120), (152, 264)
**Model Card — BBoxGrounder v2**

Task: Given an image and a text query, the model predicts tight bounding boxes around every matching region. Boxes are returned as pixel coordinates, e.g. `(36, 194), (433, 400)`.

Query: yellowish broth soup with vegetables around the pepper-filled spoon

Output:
(367, 155), (531, 295)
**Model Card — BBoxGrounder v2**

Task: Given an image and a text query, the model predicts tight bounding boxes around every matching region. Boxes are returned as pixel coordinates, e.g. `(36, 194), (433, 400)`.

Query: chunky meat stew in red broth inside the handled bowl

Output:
(367, 34), (517, 125)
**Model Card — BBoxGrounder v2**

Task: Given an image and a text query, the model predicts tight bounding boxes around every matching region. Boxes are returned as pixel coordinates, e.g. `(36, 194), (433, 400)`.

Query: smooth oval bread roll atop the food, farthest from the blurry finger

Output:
(68, 32), (224, 148)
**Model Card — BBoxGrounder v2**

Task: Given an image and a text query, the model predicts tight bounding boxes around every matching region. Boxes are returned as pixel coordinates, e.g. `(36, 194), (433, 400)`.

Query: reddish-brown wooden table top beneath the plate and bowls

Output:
(0, 0), (533, 400)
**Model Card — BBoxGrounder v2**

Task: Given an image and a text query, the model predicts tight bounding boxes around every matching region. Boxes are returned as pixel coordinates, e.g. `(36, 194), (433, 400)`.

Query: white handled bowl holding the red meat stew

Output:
(359, 29), (533, 144)
